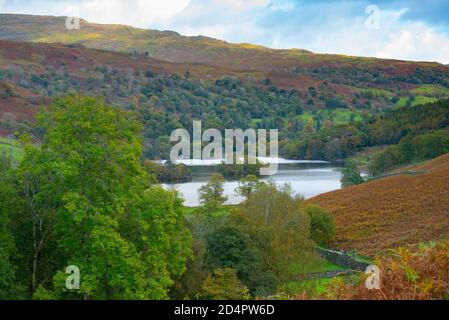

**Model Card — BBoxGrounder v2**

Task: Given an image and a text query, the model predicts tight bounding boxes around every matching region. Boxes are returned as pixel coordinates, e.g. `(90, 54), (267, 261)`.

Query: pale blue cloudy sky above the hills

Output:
(0, 0), (449, 64)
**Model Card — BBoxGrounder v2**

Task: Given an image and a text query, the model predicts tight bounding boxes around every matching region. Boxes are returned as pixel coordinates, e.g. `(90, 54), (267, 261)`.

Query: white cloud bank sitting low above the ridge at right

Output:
(258, 10), (449, 64)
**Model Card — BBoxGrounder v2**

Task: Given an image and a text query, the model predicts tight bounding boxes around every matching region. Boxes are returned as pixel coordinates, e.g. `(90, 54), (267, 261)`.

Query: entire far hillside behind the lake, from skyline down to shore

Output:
(0, 14), (449, 159)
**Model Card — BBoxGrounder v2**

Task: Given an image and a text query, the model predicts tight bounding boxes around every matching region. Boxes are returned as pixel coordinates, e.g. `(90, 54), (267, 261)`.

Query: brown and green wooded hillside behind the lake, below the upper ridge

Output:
(0, 40), (449, 160)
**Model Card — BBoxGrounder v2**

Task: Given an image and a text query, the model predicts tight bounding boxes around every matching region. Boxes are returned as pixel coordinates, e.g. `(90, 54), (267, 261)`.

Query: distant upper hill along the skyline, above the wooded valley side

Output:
(0, 14), (449, 95)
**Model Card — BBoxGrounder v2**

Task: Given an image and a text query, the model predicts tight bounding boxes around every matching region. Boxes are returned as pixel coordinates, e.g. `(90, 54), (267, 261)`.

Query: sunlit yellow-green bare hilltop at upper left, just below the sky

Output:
(0, 14), (311, 69)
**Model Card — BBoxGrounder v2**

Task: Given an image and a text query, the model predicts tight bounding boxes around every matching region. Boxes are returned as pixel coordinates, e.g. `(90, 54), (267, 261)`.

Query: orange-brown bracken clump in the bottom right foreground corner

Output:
(326, 241), (449, 300)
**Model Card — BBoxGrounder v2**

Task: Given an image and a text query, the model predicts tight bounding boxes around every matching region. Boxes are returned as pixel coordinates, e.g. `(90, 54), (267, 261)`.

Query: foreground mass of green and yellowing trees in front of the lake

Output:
(0, 96), (335, 299)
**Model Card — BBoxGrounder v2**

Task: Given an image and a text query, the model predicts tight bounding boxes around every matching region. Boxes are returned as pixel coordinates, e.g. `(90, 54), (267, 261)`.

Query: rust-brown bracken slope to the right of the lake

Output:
(309, 154), (449, 255)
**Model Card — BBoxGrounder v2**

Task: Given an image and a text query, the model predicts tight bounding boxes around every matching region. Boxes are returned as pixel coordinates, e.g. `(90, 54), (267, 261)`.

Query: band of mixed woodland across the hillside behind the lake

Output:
(0, 60), (448, 160)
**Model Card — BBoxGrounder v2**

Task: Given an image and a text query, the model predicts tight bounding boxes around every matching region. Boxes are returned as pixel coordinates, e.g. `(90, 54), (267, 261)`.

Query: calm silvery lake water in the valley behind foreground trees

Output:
(164, 159), (341, 207)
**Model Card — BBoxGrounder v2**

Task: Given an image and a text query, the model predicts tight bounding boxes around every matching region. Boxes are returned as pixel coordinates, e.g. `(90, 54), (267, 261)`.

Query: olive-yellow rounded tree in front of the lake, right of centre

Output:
(230, 185), (318, 280)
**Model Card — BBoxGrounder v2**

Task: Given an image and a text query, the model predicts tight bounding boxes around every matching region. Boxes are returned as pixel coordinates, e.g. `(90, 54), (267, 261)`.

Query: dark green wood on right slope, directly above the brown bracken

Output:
(281, 100), (449, 160)
